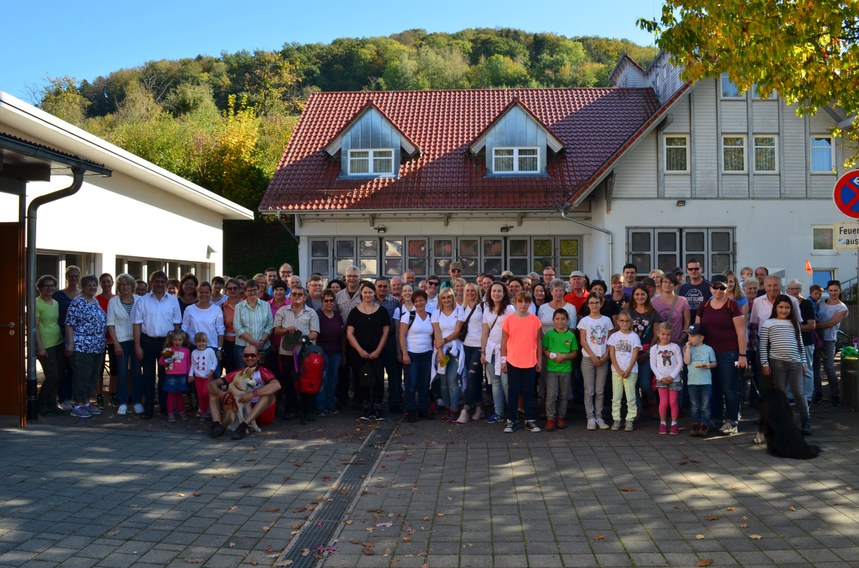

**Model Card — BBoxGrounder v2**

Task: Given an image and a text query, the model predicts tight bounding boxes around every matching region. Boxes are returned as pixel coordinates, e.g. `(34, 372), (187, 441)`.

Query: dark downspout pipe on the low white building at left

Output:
(24, 166), (86, 420)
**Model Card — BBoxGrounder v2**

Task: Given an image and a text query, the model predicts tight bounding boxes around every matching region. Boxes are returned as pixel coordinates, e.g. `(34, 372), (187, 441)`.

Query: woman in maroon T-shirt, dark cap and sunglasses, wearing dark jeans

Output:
(695, 274), (748, 435)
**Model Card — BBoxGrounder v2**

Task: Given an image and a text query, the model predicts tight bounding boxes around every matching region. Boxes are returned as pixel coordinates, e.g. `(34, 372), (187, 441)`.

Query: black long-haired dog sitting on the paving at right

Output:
(758, 388), (820, 460)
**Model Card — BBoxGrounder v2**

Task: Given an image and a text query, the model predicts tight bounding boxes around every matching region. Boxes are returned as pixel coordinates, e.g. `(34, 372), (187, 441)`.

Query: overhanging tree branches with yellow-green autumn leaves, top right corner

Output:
(638, 0), (859, 118)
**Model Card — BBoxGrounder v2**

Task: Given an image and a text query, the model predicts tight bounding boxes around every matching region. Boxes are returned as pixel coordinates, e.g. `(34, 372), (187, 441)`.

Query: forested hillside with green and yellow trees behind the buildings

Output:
(31, 28), (657, 272)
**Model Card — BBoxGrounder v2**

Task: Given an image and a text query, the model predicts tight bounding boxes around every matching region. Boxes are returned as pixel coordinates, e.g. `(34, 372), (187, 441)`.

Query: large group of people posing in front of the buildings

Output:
(35, 260), (847, 438)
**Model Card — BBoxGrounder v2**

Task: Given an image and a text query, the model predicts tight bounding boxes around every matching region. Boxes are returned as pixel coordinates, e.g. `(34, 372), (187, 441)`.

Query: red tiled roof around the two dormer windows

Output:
(260, 88), (659, 212)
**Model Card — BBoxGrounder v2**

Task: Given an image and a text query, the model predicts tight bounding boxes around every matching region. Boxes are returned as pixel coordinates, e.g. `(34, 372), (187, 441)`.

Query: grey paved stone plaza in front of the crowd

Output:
(0, 408), (859, 568)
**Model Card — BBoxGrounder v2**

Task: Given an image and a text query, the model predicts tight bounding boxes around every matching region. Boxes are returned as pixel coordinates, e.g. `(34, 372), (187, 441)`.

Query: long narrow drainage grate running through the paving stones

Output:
(275, 420), (396, 568)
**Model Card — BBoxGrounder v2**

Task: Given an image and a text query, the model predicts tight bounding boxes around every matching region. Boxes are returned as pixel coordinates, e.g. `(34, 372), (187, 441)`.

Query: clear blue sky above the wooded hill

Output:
(0, 0), (662, 102)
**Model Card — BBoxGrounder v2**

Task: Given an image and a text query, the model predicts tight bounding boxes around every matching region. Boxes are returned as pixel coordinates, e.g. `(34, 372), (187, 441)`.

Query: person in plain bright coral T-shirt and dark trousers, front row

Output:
(501, 292), (543, 434)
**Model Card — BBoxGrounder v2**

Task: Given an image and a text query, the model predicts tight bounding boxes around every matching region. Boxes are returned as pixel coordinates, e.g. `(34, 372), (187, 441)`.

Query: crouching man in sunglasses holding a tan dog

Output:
(209, 345), (280, 440)
